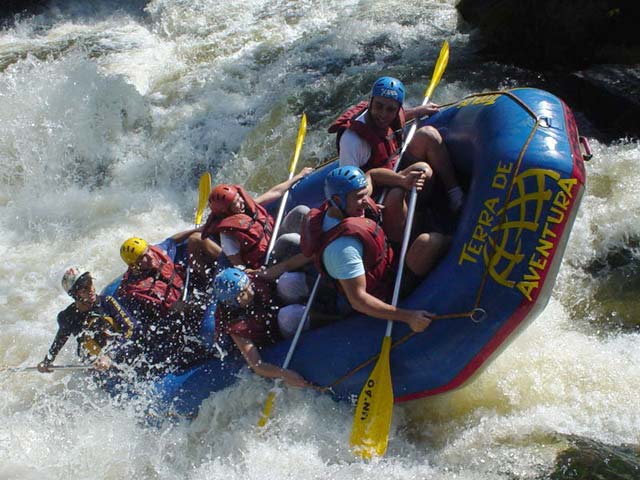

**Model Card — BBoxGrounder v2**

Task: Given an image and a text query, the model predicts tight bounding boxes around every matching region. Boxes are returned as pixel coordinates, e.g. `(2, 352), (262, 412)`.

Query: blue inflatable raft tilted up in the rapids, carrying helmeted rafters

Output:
(107, 88), (588, 416)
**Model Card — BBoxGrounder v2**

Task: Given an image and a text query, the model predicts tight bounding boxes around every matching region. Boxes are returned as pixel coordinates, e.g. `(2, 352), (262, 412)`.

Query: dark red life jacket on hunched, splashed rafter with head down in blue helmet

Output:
(215, 274), (281, 346)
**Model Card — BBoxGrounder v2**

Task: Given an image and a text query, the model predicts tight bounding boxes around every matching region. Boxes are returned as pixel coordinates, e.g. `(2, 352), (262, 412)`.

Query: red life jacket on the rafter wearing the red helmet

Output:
(202, 185), (274, 268)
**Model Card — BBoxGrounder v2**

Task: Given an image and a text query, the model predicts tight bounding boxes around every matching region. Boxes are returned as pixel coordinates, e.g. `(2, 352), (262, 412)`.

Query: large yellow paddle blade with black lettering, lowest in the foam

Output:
(351, 337), (393, 458)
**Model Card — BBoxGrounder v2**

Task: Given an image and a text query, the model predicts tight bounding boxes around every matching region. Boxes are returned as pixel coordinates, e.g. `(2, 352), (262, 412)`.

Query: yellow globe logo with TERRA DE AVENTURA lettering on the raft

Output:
(458, 163), (579, 301)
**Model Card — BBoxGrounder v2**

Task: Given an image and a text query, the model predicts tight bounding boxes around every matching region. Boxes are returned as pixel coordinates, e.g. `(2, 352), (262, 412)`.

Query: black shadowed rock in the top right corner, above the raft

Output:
(457, 0), (640, 70)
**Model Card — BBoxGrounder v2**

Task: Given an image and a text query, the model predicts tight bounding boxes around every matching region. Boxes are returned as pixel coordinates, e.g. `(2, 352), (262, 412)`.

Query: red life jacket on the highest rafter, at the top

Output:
(329, 101), (405, 172)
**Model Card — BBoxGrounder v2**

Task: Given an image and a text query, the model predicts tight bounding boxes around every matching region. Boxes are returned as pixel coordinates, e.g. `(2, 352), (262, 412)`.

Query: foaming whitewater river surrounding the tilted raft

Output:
(0, 0), (640, 480)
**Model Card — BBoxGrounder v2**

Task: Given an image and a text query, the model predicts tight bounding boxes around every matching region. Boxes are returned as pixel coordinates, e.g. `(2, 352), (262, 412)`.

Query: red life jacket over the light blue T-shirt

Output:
(300, 198), (395, 301)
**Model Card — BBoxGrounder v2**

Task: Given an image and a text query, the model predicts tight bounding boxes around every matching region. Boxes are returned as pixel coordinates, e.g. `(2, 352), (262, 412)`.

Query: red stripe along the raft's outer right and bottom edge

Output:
(394, 102), (585, 403)
